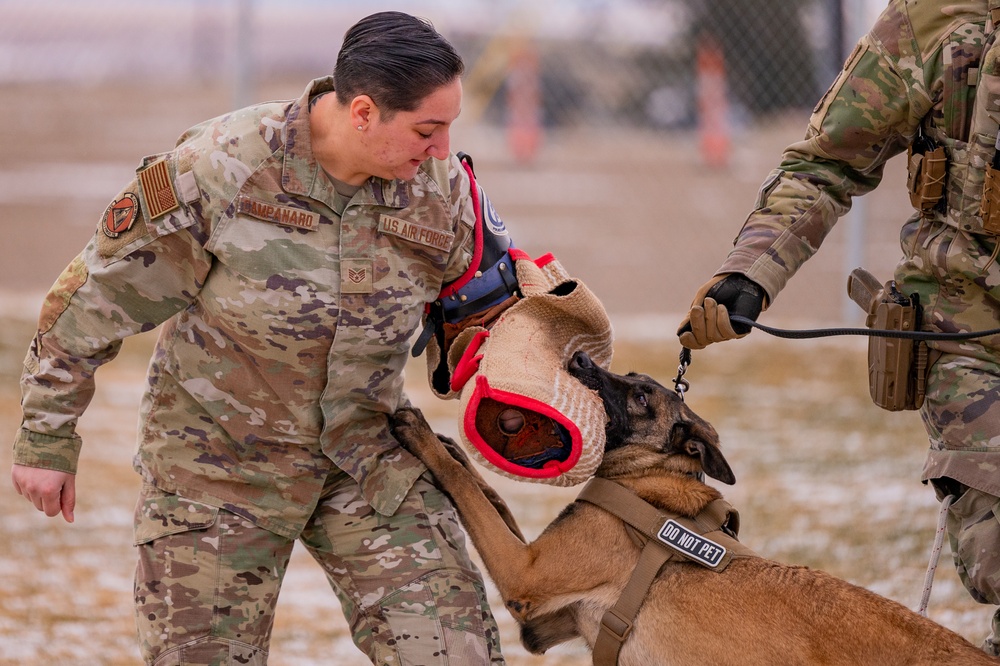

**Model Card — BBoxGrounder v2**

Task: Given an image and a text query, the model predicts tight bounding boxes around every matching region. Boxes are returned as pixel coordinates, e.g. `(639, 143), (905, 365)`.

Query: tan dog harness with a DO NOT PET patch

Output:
(576, 477), (758, 666)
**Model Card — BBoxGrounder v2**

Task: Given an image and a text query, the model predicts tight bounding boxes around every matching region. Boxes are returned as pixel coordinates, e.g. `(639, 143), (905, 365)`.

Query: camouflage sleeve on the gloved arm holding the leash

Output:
(718, 0), (940, 302)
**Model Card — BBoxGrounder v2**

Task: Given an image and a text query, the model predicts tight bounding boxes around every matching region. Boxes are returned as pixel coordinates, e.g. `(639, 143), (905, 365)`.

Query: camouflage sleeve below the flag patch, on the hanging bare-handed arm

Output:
(14, 178), (211, 473)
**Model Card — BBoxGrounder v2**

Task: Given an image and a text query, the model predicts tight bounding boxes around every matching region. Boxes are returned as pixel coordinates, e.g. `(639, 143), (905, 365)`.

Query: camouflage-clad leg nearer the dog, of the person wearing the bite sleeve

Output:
(294, 474), (503, 666)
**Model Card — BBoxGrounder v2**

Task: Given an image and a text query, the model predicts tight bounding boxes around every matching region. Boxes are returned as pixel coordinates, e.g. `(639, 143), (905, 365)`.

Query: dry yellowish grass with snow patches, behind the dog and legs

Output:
(0, 308), (991, 666)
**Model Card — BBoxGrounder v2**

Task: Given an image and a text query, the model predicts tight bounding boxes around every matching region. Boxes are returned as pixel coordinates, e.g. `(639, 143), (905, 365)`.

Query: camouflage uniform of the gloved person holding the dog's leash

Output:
(718, 0), (1000, 650)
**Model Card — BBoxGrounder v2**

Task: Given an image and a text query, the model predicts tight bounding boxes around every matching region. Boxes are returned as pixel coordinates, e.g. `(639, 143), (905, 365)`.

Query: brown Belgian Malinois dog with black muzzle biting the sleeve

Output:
(394, 353), (997, 666)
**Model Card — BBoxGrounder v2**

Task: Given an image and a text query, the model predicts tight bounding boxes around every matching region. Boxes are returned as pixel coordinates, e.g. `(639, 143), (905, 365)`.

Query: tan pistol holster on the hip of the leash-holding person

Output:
(847, 268), (928, 412)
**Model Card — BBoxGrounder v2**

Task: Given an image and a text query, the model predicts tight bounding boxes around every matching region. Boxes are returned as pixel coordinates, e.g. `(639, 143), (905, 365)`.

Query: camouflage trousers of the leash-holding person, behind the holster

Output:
(896, 221), (1000, 652)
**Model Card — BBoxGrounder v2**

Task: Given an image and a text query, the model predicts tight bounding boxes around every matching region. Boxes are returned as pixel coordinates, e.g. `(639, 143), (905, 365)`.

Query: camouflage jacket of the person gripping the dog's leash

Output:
(718, 0), (1000, 301)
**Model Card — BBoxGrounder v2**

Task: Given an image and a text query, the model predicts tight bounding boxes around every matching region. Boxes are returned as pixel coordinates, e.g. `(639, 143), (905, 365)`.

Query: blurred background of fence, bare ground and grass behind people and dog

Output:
(0, 0), (988, 666)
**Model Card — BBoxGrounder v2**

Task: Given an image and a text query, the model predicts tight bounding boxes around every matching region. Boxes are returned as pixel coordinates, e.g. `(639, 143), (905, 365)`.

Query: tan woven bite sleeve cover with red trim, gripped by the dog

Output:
(448, 249), (613, 486)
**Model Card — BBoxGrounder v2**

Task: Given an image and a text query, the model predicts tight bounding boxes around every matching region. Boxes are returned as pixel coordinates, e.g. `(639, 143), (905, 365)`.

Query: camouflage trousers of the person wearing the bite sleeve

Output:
(135, 466), (503, 666)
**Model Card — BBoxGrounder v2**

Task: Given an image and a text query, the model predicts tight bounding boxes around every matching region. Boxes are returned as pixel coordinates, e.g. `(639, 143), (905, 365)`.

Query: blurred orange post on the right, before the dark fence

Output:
(697, 39), (730, 168)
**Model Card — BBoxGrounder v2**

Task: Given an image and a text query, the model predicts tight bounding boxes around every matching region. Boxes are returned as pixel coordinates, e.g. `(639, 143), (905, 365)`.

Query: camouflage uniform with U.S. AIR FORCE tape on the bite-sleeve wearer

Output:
(14, 78), (502, 664)
